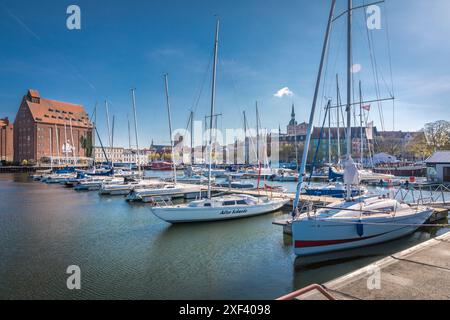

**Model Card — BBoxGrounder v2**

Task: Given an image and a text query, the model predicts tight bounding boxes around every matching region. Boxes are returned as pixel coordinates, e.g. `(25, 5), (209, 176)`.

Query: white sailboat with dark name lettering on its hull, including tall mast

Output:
(151, 20), (288, 223)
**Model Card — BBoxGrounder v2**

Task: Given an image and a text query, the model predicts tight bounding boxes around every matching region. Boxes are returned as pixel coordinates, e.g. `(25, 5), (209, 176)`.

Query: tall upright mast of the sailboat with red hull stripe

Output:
(346, 0), (352, 200)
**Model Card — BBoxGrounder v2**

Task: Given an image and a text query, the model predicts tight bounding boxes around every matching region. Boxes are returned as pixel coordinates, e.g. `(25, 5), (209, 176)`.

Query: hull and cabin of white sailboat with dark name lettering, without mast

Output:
(151, 195), (289, 223)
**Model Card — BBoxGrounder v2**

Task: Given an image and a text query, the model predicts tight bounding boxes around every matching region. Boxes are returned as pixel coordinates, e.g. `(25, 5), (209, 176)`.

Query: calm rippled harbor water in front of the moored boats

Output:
(0, 174), (450, 299)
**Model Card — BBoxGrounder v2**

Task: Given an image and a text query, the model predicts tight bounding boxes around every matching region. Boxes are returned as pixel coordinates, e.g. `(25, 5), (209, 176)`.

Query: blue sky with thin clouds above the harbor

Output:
(0, 0), (450, 147)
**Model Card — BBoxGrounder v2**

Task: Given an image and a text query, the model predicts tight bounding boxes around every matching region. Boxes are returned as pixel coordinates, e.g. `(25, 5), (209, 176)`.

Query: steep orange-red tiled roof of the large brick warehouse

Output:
(24, 89), (92, 128)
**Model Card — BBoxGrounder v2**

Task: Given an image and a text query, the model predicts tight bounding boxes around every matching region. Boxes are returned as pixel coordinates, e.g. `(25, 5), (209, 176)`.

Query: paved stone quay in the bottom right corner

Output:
(280, 232), (450, 300)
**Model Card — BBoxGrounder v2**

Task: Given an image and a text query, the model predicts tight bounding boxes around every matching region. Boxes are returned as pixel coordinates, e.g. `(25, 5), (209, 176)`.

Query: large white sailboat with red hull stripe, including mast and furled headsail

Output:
(292, 0), (433, 256)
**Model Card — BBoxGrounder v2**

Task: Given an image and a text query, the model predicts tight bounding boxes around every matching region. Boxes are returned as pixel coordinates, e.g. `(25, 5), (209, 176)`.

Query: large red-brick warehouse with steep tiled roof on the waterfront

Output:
(14, 89), (93, 163)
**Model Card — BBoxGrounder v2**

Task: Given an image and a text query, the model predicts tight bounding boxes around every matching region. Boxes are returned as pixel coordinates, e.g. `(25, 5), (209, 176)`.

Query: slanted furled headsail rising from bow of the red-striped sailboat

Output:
(292, 0), (336, 217)
